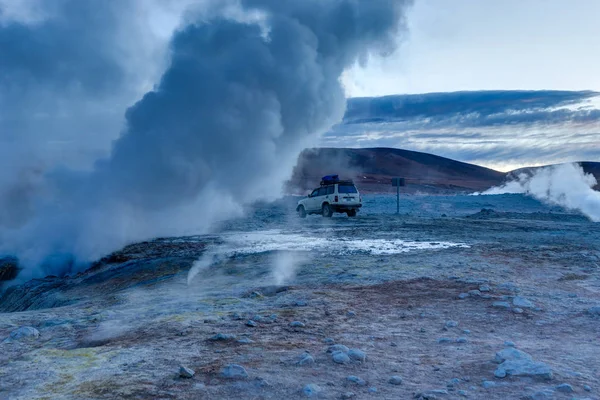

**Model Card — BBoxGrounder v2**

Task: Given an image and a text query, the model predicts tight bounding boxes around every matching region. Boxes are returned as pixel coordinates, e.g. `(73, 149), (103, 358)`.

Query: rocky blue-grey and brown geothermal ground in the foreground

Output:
(0, 195), (600, 399)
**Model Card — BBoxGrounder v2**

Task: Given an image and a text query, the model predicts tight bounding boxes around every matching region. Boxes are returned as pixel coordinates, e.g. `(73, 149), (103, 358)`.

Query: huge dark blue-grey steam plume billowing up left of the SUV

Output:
(0, 0), (409, 277)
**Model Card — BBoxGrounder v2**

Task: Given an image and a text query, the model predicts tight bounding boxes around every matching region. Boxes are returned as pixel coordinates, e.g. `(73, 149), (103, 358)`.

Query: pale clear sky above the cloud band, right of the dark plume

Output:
(344, 0), (600, 97)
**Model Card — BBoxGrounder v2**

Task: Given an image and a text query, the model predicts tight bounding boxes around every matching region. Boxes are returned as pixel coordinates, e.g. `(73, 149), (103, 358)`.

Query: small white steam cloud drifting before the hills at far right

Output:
(481, 164), (600, 222)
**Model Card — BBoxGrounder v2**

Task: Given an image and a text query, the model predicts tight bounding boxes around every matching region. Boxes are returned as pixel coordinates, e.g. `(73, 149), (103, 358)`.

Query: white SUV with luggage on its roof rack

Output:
(296, 179), (362, 218)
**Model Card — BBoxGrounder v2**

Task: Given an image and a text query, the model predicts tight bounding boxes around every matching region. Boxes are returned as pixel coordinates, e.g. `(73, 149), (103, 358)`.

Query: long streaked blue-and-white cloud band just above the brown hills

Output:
(322, 91), (600, 170)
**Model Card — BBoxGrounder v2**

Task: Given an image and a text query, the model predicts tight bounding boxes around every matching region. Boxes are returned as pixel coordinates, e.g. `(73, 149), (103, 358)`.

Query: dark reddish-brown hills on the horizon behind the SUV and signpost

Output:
(287, 147), (600, 194)
